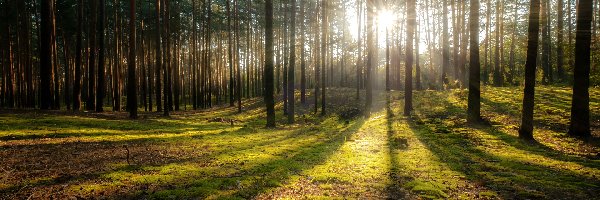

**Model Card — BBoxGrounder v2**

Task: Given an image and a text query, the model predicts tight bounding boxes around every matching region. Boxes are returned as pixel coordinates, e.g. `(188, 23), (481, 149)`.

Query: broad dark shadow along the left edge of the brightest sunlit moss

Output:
(101, 119), (365, 199)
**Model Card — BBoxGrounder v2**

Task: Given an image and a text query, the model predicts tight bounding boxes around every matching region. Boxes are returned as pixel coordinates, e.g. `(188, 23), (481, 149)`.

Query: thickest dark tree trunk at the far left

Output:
(40, 0), (55, 110)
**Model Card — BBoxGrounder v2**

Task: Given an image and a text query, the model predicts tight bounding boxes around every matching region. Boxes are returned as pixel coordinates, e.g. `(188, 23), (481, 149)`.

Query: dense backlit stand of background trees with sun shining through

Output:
(0, 0), (600, 141)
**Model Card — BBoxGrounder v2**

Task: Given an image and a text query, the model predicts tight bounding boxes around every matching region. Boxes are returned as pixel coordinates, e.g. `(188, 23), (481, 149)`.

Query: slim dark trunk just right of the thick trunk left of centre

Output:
(287, 0), (296, 124)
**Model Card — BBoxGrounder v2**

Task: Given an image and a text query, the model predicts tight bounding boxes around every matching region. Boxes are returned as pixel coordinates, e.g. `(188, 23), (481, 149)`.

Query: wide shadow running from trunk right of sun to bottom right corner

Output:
(409, 112), (600, 199)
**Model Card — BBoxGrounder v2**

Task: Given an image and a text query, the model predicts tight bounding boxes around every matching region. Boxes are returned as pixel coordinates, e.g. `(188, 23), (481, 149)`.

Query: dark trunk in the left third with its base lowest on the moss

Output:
(127, 0), (137, 119)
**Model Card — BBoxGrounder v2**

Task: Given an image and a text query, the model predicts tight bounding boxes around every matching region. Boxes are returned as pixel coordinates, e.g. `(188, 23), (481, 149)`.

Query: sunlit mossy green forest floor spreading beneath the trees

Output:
(0, 87), (600, 199)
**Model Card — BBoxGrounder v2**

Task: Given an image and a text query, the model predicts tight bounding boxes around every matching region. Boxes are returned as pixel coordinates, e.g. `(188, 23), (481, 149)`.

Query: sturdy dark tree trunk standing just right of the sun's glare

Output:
(404, 0), (417, 116)
